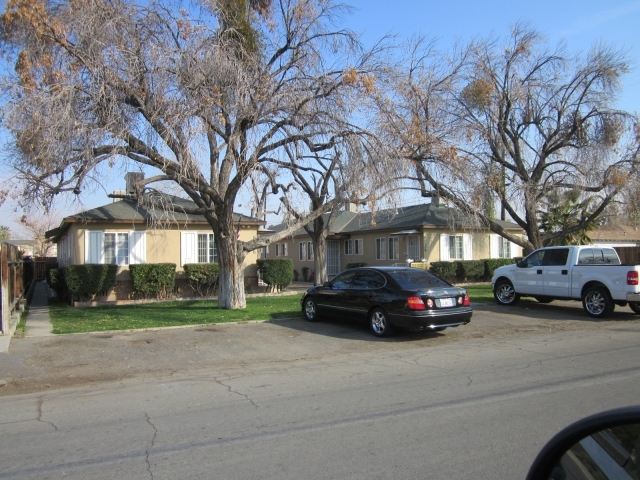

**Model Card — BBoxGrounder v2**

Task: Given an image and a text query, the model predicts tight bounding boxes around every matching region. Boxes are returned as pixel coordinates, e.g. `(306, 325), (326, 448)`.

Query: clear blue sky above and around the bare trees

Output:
(0, 0), (640, 233)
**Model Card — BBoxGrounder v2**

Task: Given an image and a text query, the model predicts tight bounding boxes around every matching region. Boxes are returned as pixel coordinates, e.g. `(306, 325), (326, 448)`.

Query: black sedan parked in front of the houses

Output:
(302, 267), (472, 337)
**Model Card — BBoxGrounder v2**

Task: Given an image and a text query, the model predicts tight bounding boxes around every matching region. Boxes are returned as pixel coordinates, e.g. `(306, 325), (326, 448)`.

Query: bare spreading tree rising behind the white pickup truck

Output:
(382, 25), (640, 251)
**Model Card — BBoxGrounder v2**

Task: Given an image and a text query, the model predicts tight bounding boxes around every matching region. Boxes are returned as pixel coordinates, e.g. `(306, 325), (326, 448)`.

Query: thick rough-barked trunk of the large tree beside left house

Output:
(216, 232), (247, 310)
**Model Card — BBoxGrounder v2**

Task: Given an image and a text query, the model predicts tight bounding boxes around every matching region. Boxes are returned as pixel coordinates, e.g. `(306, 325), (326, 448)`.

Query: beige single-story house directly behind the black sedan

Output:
(261, 200), (524, 276)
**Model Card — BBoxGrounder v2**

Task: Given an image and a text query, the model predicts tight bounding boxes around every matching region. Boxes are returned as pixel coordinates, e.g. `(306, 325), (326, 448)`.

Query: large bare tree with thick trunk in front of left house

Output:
(1, 0), (384, 308)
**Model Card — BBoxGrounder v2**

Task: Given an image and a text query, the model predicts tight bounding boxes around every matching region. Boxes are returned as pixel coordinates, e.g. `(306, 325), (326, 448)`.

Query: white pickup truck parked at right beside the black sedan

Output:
(491, 245), (640, 318)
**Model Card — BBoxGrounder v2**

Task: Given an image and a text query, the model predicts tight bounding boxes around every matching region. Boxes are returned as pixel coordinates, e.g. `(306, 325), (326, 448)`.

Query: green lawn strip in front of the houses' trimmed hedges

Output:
(50, 285), (493, 334)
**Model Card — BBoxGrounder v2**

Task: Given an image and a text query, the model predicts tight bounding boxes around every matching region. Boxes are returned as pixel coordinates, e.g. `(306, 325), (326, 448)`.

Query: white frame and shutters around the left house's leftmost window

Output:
(84, 230), (147, 267)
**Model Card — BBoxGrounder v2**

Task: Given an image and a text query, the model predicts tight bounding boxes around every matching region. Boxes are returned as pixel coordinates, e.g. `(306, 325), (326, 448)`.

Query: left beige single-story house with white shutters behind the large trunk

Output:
(46, 196), (265, 300)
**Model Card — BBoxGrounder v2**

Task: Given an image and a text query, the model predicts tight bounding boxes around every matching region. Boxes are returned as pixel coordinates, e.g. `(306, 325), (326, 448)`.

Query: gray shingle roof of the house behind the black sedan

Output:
(270, 203), (521, 236)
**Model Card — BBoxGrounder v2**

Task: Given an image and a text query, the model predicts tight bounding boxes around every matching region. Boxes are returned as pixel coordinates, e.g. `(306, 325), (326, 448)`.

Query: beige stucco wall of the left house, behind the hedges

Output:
(59, 223), (257, 280)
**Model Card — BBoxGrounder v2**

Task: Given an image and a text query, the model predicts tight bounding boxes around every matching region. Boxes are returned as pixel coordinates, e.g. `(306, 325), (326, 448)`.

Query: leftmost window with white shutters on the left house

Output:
(85, 230), (146, 266)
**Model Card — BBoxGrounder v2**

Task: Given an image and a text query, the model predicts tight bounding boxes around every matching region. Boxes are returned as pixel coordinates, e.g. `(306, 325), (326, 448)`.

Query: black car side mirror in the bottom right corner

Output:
(527, 406), (640, 480)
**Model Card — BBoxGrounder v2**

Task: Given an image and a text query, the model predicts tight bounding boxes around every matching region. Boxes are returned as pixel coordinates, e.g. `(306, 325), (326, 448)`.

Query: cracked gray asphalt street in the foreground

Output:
(0, 301), (640, 479)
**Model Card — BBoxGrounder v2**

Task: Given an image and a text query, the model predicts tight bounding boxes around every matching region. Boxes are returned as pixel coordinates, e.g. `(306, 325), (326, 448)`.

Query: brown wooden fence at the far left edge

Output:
(0, 242), (24, 335)
